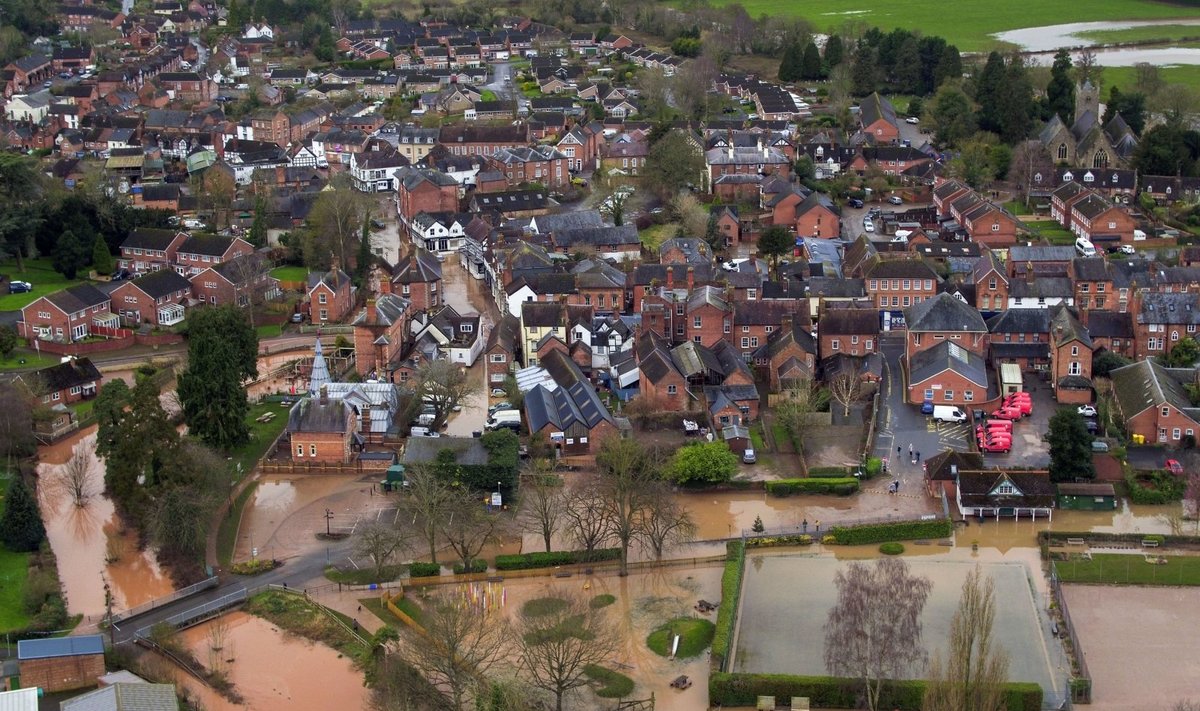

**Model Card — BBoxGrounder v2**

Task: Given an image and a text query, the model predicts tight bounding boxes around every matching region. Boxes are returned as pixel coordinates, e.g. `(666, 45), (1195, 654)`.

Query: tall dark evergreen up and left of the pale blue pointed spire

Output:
(179, 306), (258, 450)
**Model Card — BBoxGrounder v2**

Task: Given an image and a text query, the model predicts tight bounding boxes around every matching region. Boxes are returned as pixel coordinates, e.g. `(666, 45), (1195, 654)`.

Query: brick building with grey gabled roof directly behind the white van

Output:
(907, 341), (988, 407)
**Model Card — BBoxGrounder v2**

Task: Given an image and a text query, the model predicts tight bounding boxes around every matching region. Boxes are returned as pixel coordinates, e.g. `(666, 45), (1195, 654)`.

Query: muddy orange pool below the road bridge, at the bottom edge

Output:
(168, 613), (368, 711)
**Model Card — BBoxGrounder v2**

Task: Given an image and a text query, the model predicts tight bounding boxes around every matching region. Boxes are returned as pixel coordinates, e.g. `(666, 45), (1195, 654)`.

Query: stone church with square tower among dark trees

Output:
(1038, 82), (1138, 169)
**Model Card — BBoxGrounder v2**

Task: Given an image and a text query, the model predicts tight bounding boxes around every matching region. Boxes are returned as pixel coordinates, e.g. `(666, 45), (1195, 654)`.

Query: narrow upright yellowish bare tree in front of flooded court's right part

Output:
(922, 564), (1008, 711)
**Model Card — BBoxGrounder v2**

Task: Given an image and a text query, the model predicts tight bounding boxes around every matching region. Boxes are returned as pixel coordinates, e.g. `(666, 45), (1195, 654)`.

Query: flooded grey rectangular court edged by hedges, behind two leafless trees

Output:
(733, 554), (1066, 698)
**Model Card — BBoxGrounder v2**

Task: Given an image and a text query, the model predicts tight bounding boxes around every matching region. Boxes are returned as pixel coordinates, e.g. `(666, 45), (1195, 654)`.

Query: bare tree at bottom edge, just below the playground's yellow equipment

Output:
(404, 595), (506, 711)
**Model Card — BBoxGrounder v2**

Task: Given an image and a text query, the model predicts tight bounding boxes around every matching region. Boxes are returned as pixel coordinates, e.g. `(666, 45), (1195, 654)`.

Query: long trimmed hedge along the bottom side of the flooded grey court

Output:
(708, 673), (1043, 711)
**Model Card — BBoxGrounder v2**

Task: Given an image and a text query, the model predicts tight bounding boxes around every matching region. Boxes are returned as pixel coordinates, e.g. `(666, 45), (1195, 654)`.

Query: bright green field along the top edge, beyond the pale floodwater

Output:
(713, 0), (1200, 52)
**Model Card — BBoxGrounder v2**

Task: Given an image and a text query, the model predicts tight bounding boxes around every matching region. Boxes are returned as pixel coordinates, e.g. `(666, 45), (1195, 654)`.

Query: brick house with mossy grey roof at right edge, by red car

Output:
(1109, 358), (1200, 446)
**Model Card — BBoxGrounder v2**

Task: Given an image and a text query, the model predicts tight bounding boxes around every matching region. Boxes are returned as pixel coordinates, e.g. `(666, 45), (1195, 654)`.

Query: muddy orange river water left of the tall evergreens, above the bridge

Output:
(37, 428), (174, 625)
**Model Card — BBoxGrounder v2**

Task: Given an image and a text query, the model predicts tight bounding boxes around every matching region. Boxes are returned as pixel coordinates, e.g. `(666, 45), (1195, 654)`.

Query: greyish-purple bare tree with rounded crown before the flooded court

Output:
(824, 558), (932, 711)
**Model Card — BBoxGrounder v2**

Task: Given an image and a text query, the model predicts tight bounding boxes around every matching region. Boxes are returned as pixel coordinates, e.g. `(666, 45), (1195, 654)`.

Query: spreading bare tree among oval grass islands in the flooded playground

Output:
(514, 597), (617, 711)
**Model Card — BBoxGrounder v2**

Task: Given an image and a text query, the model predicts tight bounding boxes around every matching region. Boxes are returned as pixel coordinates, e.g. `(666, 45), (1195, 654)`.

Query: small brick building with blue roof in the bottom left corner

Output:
(17, 634), (104, 693)
